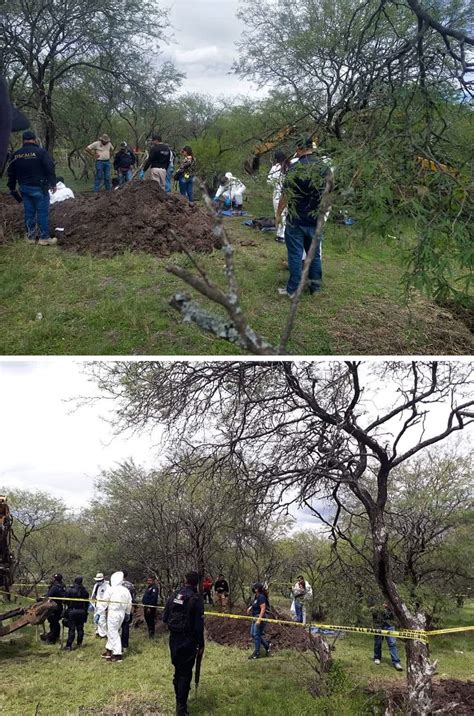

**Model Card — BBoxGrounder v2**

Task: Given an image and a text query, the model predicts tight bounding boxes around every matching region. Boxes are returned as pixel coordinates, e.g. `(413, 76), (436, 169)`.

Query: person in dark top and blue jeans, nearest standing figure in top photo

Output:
(276, 137), (332, 298)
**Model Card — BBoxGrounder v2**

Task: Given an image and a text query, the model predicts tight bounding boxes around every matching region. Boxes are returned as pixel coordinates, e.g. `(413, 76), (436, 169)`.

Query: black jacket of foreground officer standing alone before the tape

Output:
(163, 586), (204, 646)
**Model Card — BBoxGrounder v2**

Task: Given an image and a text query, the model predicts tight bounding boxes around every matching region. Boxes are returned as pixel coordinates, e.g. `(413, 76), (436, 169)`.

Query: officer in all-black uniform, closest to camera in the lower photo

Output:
(163, 572), (204, 716)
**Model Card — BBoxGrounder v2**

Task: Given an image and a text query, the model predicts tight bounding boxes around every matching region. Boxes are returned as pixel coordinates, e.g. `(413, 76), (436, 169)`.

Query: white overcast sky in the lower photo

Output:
(0, 358), (472, 529)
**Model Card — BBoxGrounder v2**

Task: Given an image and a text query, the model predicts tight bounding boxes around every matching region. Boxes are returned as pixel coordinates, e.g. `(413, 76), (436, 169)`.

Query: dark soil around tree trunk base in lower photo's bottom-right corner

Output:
(384, 679), (474, 716)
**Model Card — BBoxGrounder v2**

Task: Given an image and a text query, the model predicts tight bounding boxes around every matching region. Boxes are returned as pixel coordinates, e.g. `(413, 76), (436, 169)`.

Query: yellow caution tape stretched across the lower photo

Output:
(0, 590), (474, 643)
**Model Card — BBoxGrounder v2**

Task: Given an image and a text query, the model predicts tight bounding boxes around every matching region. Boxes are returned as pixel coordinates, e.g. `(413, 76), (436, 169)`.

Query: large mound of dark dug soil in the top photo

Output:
(0, 181), (216, 257)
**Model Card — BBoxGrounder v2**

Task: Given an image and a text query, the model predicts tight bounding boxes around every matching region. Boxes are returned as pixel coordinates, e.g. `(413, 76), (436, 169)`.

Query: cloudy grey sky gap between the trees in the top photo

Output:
(163, 0), (261, 98)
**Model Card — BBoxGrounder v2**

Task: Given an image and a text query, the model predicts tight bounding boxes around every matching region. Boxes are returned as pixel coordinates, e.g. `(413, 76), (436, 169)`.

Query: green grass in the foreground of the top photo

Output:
(0, 178), (472, 355)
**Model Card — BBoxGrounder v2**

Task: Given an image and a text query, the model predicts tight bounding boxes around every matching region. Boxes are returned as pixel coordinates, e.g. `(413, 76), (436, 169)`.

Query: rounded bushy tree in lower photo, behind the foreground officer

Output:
(86, 454), (278, 591)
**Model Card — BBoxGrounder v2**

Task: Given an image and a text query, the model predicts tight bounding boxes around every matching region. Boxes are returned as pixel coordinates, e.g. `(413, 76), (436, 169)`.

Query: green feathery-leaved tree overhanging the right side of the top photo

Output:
(235, 0), (474, 304)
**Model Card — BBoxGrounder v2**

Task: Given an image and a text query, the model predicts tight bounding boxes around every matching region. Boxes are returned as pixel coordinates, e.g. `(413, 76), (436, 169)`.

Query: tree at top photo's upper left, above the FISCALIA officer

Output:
(0, 0), (181, 151)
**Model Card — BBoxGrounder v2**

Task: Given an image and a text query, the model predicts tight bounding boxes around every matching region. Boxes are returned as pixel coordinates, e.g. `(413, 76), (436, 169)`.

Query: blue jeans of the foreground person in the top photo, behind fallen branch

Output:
(285, 221), (323, 293)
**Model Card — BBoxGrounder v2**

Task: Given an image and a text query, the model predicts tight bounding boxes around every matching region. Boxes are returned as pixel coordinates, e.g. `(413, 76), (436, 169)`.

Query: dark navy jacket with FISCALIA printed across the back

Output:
(7, 144), (56, 192)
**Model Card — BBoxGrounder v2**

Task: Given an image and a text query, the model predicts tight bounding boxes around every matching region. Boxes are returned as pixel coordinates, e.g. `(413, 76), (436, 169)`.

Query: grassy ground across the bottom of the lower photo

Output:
(0, 603), (474, 716)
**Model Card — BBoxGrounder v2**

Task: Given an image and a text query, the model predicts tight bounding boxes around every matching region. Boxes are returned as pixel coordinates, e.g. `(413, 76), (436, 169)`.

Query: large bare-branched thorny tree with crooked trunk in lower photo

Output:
(91, 361), (474, 714)
